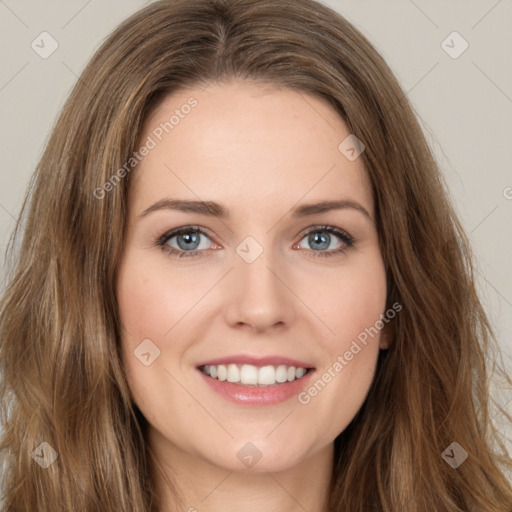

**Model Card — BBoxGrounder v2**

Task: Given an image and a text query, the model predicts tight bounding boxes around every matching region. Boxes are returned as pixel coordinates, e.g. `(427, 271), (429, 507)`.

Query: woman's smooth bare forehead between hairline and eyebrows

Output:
(130, 81), (373, 216)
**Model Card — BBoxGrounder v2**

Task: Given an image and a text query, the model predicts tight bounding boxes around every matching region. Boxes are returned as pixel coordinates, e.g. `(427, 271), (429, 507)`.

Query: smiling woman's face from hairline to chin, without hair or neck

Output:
(117, 82), (386, 471)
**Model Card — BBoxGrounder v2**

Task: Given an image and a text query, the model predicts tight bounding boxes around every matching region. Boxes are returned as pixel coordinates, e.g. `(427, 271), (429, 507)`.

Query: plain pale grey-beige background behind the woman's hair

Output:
(0, 0), (512, 446)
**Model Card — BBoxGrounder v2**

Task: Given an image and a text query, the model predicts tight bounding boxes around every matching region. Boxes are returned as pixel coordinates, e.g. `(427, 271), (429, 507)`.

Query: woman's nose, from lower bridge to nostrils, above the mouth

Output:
(224, 247), (298, 332)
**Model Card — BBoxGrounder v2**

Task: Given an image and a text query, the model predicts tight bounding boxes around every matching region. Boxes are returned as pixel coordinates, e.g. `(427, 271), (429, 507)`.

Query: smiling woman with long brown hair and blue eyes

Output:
(0, 0), (512, 512)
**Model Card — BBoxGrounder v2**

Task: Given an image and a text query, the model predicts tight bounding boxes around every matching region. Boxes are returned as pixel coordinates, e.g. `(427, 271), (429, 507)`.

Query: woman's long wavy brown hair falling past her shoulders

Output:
(0, 0), (512, 512)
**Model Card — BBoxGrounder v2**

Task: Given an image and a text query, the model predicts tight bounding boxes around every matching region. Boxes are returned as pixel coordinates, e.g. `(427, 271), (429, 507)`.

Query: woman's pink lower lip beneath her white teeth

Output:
(198, 370), (315, 406)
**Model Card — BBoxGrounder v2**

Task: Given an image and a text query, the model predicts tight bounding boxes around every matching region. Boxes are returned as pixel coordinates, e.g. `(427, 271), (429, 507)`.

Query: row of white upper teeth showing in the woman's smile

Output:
(203, 364), (307, 386)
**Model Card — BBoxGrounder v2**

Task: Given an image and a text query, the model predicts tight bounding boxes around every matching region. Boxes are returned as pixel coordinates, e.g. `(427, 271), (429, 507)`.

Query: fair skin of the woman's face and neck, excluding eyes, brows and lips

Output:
(117, 81), (388, 512)
